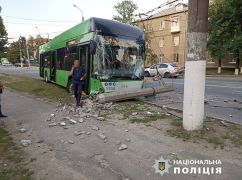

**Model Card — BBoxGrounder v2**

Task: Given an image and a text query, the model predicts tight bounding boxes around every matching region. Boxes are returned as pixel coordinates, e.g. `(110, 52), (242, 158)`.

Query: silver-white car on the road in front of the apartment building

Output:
(145, 63), (184, 78)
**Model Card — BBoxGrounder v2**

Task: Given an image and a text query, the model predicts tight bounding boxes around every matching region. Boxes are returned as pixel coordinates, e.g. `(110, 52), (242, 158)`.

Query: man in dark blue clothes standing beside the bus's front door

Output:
(70, 60), (86, 106)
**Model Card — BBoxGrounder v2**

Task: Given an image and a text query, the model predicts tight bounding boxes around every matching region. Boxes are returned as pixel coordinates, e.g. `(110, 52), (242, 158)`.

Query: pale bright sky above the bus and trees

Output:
(0, 0), (185, 41)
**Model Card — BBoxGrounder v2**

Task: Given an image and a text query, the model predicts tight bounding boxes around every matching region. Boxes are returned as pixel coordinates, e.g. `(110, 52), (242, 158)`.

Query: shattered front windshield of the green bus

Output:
(93, 36), (144, 79)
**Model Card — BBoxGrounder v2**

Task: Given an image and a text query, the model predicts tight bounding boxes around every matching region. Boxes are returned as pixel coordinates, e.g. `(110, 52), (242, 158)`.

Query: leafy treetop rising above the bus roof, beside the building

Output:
(113, 0), (138, 25)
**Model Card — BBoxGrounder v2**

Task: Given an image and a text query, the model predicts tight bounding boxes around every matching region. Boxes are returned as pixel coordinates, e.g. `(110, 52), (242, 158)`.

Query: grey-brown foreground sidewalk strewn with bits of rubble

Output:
(2, 90), (242, 180)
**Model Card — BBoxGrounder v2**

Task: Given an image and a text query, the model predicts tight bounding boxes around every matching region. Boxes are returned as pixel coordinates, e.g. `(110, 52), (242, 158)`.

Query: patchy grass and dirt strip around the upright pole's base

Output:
(99, 100), (242, 149)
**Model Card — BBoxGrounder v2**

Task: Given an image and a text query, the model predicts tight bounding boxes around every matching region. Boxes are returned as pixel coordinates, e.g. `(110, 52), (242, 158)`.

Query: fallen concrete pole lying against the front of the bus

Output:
(97, 87), (175, 103)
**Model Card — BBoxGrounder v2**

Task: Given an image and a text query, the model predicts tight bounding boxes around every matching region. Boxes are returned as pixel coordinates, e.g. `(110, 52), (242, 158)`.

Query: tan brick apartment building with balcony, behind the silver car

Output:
(139, 3), (188, 66)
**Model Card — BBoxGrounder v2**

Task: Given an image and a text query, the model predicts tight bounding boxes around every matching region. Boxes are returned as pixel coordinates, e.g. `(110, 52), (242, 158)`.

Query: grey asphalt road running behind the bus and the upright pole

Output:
(0, 66), (242, 124)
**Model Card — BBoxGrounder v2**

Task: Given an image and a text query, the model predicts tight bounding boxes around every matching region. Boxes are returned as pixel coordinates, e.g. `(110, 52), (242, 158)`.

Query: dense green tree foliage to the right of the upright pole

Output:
(208, 0), (242, 67)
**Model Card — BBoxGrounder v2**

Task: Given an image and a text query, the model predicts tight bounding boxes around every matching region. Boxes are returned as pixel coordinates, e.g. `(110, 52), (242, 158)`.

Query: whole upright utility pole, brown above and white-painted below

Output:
(183, 0), (209, 130)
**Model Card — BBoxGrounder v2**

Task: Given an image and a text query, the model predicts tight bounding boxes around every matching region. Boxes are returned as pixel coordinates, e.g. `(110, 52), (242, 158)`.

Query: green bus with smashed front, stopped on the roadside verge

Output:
(40, 18), (145, 95)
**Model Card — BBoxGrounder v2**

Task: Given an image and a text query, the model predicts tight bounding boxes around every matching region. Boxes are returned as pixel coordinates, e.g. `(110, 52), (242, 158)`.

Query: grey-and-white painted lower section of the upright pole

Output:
(183, 32), (207, 131)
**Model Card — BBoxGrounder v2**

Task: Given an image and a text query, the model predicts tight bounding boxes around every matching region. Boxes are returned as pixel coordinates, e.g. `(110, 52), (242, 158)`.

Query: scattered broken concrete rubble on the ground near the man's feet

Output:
(46, 99), (131, 151)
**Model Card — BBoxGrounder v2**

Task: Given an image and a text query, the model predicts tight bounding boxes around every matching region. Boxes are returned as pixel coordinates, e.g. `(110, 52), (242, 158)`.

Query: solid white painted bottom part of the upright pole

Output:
(183, 60), (206, 130)
